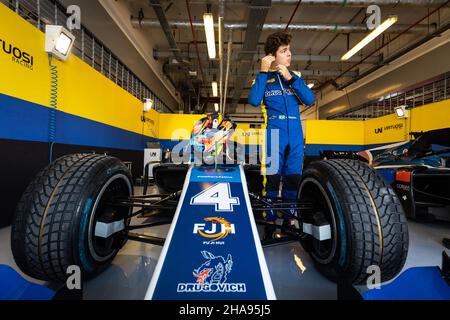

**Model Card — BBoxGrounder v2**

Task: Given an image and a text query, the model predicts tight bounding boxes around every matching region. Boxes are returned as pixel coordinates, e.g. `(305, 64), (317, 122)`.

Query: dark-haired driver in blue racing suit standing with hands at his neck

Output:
(248, 32), (315, 237)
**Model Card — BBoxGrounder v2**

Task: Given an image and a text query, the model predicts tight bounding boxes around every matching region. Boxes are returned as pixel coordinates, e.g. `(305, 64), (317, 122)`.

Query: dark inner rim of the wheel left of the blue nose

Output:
(88, 174), (133, 262)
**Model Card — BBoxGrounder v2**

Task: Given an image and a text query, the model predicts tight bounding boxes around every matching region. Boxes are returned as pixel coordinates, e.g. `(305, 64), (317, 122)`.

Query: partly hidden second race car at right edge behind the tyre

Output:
(322, 128), (450, 221)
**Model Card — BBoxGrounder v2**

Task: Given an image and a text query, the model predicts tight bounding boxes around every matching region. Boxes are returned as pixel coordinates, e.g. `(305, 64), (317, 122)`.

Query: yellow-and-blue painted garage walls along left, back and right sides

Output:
(0, 4), (450, 227)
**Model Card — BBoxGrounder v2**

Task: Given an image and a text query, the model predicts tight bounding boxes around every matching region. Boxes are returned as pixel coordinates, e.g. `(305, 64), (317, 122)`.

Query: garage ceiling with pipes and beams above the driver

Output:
(74, 0), (450, 113)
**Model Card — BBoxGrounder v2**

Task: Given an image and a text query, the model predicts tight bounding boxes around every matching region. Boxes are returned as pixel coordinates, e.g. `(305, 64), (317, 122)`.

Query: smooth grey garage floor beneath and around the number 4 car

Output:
(0, 187), (450, 300)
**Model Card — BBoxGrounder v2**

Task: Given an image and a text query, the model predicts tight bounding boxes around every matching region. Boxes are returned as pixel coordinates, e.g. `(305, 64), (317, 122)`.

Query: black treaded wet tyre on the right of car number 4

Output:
(298, 159), (409, 284)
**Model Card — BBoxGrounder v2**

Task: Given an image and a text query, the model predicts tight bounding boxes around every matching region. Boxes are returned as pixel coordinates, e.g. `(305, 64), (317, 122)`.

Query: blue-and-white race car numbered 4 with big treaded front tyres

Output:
(11, 117), (409, 299)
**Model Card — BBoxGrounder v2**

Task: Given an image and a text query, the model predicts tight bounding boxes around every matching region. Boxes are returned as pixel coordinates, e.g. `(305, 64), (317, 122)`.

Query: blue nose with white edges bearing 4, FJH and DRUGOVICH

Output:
(146, 166), (275, 300)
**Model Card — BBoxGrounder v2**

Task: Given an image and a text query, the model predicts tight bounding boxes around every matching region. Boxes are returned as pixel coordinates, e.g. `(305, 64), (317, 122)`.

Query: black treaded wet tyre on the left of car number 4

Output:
(11, 154), (133, 282)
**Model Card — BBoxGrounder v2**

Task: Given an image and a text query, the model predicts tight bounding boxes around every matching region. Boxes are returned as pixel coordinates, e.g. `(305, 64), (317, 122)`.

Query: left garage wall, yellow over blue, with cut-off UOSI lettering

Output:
(0, 4), (158, 226)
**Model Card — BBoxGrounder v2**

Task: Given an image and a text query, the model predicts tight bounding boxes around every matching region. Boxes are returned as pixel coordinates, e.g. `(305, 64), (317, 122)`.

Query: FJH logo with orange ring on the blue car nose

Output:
(193, 217), (236, 244)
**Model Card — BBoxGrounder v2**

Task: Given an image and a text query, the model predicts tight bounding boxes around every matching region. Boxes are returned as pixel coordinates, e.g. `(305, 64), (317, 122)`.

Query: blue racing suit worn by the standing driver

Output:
(248, 71), (315, 221)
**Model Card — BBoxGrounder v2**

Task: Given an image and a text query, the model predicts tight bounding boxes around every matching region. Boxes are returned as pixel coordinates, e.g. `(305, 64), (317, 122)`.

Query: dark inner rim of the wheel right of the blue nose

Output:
(298, 178), (337, 264)
